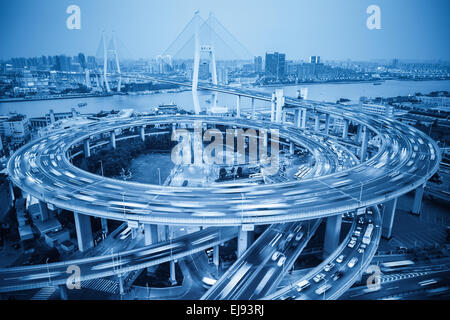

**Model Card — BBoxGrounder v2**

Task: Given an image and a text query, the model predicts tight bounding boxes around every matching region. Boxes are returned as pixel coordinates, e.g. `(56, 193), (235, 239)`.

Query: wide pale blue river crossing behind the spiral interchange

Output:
(0, 80), (450, 117)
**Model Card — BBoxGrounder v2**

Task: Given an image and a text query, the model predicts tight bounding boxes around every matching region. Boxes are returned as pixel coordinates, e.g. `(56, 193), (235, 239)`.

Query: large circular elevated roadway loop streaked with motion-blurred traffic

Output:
(8, 112), (440, 226)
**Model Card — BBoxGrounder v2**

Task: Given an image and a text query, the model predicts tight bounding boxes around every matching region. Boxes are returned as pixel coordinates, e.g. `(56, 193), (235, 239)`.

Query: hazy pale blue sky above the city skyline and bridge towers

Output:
(0, 0), (450, 60)
